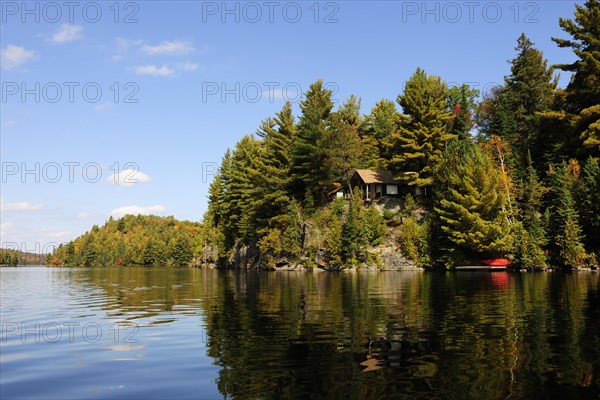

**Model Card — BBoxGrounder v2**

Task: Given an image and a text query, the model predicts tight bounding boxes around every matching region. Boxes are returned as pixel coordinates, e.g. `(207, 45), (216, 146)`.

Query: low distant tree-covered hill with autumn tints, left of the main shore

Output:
(49, 215), (202, 267)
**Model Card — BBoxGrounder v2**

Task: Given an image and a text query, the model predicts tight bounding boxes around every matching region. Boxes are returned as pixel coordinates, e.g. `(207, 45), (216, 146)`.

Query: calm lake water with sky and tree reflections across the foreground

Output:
(0, 267), (600, 399)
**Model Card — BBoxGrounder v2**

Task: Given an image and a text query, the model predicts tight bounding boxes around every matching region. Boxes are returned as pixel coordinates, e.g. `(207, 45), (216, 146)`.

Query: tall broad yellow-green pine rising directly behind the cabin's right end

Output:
(390, 68), (454, 186)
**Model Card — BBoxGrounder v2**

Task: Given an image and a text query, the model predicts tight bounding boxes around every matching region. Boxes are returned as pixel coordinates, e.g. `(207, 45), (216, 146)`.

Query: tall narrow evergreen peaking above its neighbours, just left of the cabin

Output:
(291, 80), (333, 204)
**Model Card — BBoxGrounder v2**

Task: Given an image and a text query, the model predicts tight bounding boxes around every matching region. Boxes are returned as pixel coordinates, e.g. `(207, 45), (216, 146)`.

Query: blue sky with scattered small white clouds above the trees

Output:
(0, 1), (574, 251)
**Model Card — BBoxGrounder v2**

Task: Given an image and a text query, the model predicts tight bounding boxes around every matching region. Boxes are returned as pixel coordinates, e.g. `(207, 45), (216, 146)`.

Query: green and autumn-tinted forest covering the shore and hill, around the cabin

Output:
(49, 0), (600, 270)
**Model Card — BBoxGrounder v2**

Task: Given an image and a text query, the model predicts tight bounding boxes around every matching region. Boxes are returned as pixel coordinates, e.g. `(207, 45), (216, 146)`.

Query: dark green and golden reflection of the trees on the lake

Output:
(72, 268), (600, 399)
